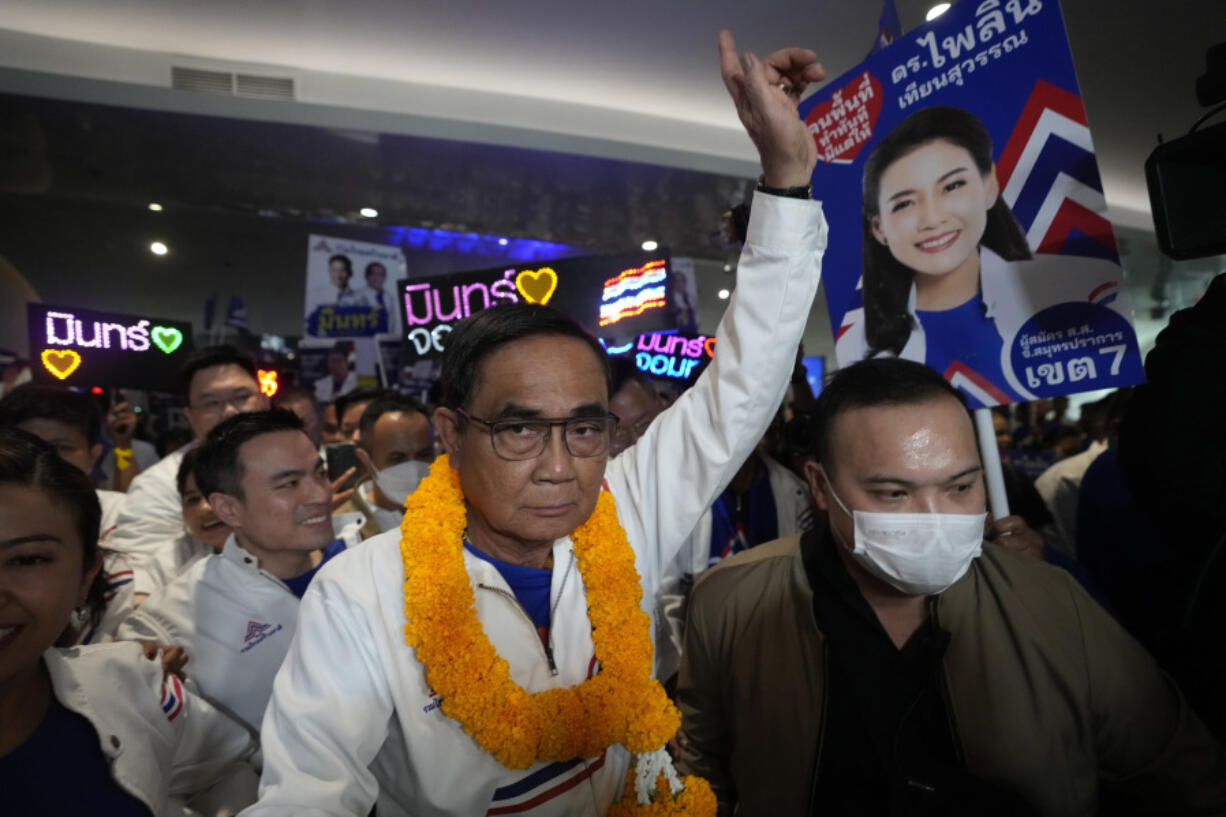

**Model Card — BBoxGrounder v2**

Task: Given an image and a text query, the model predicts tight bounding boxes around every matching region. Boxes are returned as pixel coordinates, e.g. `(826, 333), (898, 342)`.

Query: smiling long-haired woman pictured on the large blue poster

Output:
(836, 105), (1128, 406)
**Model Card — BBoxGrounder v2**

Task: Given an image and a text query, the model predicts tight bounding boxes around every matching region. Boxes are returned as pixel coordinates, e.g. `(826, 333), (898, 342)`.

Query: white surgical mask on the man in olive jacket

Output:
(819, 466), (988, 596)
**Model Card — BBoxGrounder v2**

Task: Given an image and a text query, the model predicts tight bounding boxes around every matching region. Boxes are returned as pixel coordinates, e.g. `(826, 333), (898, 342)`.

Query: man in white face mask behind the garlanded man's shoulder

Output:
(337, 391), (434, 539)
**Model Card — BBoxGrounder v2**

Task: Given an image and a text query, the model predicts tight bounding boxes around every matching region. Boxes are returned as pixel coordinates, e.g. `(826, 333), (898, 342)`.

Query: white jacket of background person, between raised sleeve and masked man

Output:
(656, 454), (813, 681)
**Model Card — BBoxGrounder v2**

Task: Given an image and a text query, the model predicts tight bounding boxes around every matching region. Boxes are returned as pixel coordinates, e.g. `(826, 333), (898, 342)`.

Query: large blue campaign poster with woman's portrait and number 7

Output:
(801, 0), (1144, 407)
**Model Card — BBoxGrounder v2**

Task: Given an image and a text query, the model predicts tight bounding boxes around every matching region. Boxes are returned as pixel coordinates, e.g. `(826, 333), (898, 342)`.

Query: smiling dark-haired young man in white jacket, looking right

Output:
(118, 410), (360, 732)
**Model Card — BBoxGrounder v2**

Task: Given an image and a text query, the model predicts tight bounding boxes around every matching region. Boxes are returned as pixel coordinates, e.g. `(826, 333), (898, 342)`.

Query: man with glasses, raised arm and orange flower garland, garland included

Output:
(244, 33), (826, 817)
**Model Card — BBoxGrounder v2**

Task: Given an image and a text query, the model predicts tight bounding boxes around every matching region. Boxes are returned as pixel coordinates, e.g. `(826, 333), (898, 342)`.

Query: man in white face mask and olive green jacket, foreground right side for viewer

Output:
(677, 358), (1226, 817)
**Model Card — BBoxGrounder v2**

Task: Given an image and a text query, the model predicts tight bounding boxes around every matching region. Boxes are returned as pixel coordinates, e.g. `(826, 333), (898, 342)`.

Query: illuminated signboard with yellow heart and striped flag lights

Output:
(400, 253), (676, 364)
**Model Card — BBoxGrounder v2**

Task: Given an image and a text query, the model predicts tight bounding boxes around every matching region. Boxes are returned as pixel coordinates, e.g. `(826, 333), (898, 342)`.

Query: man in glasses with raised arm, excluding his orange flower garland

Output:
(244, 33), (826, 817)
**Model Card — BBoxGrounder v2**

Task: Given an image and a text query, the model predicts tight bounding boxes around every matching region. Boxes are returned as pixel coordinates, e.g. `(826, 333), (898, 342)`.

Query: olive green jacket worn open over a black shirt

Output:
(677, 536), (1226, 817)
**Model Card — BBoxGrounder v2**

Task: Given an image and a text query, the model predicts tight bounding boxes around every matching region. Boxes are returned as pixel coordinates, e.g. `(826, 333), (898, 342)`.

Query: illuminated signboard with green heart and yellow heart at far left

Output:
(26, 303), (191, 391)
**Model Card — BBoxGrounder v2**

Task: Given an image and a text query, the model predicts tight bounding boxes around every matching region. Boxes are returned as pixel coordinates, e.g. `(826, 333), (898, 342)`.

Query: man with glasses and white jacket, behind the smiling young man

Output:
(107, 346), (268, 602)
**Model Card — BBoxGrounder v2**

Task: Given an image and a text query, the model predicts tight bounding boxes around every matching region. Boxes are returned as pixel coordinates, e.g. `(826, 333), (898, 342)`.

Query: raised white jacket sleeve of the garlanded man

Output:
(606, 188), (826, 586)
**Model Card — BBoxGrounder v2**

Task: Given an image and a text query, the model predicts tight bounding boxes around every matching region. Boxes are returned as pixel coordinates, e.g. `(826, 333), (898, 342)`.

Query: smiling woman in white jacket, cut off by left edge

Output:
(0, 428), (255, 817)
